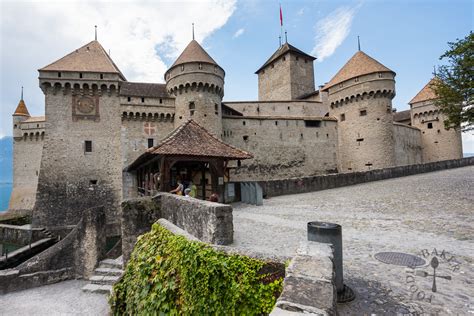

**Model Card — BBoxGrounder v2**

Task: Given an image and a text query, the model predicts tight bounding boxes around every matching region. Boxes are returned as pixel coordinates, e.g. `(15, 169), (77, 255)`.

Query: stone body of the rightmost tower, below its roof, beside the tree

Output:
(411, 101), (463, 162)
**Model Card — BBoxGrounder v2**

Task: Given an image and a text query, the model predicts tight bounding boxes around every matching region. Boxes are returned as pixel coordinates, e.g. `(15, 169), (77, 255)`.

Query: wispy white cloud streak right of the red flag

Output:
(311, 5), (360, 62)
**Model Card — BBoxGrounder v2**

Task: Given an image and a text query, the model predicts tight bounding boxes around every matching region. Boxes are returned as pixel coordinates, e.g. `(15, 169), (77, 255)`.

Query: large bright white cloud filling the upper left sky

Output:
(0, 0), (236, 138)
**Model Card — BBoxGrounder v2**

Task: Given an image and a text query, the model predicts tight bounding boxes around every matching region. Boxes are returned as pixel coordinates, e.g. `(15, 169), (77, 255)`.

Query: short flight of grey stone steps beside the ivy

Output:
(82, 256), (123, 294)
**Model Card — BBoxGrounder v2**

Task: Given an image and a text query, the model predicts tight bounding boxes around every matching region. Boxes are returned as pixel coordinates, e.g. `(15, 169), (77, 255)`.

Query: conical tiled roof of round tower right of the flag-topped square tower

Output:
(323, 51), (395, 90)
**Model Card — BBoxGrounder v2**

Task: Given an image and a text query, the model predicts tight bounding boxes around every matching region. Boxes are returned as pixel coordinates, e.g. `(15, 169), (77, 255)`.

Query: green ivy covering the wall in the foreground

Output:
(110, 223), (284, 315)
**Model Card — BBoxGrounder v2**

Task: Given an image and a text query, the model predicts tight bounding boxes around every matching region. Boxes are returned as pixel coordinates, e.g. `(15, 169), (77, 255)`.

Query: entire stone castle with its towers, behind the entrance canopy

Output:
(10, 40), (462, 230)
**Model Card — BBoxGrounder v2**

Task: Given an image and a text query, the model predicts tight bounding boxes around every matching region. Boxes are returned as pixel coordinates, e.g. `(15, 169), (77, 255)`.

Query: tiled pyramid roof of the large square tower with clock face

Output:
(39, 41), (125, 80)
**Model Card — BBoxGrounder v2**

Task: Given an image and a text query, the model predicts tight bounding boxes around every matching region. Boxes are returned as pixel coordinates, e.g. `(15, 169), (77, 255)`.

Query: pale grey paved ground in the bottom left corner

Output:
(0, 280), (110, 316)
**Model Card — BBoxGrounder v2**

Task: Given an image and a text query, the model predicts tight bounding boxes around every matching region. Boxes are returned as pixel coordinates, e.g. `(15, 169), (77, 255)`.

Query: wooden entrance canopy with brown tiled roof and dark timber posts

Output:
(124, 120), (253, 197)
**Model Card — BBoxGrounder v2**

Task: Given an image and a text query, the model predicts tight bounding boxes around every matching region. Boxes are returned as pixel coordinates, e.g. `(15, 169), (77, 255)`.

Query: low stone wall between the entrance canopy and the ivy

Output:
(122, 193), (234, 263)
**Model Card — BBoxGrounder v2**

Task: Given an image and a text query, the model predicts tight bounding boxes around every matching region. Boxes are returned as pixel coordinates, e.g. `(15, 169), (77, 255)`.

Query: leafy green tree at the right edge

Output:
(432, 31), (474, 131)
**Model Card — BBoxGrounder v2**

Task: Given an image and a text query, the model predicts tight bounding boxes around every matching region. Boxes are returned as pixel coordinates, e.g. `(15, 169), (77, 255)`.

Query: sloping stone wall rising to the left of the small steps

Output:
(0, 207), (106, 294)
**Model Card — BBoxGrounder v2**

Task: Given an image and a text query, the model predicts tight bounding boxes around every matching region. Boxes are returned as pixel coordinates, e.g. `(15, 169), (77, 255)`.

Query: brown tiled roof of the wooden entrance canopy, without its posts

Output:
(125, 120), (253, 171)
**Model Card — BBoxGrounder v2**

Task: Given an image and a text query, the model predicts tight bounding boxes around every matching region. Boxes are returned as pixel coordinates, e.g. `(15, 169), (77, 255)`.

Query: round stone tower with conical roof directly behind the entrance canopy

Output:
(165, 40), (225, 138)
